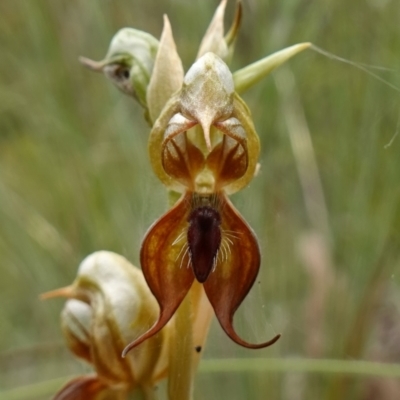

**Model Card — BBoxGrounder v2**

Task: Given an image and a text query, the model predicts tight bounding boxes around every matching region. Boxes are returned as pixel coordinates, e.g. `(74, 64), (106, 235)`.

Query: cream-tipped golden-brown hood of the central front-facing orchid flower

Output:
(149, 53), (260, 194)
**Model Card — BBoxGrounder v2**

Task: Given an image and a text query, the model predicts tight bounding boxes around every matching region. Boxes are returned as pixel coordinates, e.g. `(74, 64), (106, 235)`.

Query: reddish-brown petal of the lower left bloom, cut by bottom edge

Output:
(53, 375), (116, 400)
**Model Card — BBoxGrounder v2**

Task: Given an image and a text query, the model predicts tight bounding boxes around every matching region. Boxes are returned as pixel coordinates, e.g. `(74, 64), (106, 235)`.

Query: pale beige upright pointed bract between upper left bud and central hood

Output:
(147, 15), (184, 122)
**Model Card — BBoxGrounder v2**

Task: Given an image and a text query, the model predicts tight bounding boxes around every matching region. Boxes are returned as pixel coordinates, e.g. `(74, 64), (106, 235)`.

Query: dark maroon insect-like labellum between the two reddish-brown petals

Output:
(187, 206), (221, 283)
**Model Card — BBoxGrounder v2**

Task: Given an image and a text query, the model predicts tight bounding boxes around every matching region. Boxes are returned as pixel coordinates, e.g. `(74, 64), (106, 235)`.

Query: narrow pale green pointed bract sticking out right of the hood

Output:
(233, 42), (312, 93)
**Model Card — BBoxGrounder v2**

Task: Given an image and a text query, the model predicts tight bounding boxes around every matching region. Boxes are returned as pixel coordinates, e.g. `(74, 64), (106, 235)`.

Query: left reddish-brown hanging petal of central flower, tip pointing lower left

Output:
(122, 193), (194, 356)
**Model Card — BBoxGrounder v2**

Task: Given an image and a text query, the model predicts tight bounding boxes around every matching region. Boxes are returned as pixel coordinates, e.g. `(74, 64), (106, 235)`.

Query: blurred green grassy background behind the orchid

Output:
(0, 0), (400, 400)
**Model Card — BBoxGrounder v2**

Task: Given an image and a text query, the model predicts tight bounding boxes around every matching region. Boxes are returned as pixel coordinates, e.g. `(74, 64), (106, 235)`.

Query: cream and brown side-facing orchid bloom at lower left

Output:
(43, 251), (170, 400)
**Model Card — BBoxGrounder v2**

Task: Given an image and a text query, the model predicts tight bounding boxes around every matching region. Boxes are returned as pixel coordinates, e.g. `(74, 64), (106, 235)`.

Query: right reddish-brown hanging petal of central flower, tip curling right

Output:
(204, 195), (280, 349)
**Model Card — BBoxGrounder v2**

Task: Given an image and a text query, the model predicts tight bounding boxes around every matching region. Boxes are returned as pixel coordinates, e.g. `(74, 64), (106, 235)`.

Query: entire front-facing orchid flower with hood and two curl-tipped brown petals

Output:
(123, 53), (280, 355)
